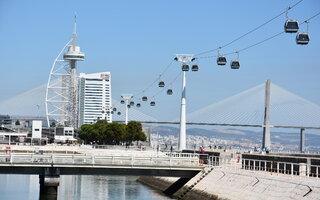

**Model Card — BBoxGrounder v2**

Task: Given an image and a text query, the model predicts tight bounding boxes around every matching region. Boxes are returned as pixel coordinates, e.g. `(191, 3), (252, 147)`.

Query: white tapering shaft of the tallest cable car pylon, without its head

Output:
(179, 71), (186, 151)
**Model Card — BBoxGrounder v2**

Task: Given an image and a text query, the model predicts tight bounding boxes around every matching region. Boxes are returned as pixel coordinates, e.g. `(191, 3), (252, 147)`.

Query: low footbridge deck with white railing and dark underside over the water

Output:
(0, 154), (203, 178)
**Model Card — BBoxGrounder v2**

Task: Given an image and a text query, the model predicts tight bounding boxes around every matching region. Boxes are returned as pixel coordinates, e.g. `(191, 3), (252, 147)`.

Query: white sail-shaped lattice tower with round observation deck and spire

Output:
(46, 17), (85, 128)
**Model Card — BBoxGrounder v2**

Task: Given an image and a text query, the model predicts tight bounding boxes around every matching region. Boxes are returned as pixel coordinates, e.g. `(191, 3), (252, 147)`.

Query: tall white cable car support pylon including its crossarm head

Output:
(176, 54), (194, 151)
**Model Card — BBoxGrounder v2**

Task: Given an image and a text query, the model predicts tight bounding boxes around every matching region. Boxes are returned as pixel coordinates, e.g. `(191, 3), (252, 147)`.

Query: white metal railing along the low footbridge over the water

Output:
(0, 153), (199, 168)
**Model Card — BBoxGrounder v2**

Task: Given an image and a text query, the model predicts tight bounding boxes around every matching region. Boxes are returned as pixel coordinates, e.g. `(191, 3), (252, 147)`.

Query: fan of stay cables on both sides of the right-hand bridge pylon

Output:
(187, 84), (320, 128)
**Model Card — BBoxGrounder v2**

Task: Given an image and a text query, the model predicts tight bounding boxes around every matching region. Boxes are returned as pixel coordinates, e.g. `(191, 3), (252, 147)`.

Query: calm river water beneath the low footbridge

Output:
(0, 175), (171, 200)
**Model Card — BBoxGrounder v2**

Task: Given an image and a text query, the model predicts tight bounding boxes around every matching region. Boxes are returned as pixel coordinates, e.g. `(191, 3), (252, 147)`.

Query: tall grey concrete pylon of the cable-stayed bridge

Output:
(262, 79), (270, 149)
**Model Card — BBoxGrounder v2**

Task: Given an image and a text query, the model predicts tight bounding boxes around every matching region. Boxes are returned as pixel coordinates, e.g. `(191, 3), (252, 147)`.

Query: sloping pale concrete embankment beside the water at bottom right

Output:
(139, 168), (320, 200)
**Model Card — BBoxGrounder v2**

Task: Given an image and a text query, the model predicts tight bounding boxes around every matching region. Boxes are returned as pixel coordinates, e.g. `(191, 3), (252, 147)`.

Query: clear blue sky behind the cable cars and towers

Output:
(0, 0), (320, 120)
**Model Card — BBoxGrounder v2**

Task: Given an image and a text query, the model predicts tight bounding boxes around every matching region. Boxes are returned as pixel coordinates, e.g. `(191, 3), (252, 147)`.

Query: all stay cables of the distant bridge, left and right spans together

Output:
(0, 81), (320, 129)
